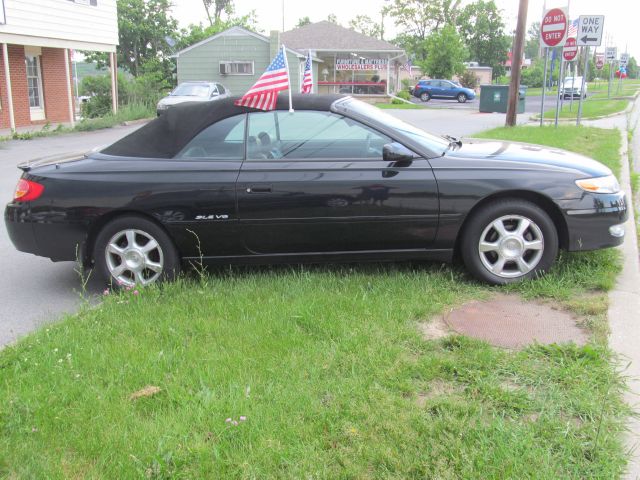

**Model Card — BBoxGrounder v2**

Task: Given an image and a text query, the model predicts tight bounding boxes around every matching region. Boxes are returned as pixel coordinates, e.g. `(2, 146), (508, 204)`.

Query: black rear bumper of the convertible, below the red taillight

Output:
(4, 202), (87, 262)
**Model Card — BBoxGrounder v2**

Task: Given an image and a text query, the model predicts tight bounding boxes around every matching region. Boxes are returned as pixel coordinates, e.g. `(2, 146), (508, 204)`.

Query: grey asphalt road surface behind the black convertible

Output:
(0, 108), (528, 346)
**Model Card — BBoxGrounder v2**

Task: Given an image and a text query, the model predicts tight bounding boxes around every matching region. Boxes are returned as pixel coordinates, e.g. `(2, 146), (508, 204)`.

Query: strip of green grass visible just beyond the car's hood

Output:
(475, 124), (620, 176)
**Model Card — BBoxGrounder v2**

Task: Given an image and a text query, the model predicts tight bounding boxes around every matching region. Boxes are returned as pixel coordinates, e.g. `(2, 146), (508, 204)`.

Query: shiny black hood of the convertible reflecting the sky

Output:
(445, 139), (611, 177)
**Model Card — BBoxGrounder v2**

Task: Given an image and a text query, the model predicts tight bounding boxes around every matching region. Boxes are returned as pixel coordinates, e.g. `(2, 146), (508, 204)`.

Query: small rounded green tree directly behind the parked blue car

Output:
(420, 25), (467, 79)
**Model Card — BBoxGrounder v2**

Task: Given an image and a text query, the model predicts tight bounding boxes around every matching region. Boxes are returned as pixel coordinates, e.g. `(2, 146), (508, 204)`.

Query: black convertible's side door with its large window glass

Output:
(237, 111), (438, 254)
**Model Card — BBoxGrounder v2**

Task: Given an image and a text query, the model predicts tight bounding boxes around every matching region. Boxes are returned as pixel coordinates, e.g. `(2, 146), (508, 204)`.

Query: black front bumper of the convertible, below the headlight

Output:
(561, 192), (629, 251)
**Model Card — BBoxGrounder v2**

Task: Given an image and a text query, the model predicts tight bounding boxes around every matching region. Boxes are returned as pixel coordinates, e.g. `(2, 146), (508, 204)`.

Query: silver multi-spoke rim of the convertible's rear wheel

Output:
(105, 229), (164, 287)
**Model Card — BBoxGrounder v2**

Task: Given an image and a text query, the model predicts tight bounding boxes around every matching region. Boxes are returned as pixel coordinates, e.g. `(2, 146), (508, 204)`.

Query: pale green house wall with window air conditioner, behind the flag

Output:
(176, 27), (322, 95)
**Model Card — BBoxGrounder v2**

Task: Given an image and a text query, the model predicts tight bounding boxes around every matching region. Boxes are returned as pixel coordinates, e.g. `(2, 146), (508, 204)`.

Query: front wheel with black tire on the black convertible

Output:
(460, 199), (558, 285)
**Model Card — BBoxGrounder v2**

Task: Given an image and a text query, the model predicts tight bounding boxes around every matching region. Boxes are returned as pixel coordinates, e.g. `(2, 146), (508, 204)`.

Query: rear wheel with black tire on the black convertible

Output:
(93, 215), (180, 288)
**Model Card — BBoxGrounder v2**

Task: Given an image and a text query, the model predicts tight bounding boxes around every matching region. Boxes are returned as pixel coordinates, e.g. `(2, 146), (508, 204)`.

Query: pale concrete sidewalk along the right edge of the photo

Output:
(600, 100), (640, 480)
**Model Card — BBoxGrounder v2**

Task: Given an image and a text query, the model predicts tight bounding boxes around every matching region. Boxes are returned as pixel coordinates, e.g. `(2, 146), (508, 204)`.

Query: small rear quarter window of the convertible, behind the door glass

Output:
(174, 115), (245, 160)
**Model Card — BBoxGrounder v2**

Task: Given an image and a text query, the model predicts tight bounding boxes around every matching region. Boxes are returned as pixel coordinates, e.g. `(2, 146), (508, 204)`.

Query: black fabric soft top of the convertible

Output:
(101, 94), (346, 158)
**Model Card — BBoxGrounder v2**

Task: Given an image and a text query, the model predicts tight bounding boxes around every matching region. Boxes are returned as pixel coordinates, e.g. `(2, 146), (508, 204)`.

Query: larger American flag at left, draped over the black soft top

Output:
(233, 45), (289, 110)
